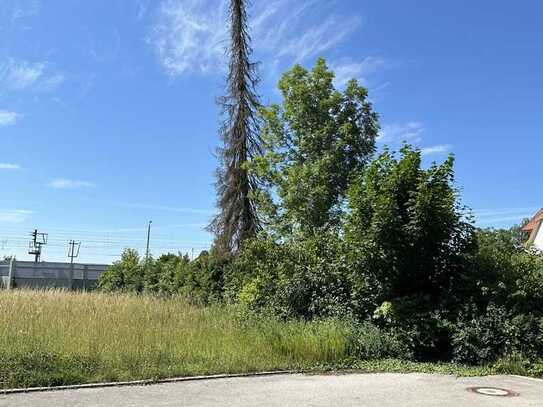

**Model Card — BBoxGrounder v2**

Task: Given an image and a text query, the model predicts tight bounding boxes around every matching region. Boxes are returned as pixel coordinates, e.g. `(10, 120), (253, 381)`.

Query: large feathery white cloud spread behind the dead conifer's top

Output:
(148, 0), (360, 77)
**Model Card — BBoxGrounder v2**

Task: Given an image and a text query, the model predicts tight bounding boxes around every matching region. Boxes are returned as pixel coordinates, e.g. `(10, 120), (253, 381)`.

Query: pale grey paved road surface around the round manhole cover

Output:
(0, 374), (543, 407)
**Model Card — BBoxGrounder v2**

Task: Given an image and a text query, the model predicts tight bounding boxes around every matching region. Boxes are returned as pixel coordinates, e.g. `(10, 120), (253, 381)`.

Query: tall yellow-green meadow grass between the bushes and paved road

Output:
(0, 290), (540, 388)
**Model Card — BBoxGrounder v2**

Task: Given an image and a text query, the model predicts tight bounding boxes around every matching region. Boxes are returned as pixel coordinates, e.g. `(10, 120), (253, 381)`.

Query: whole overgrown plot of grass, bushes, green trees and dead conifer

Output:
(0, 0), (543, 387)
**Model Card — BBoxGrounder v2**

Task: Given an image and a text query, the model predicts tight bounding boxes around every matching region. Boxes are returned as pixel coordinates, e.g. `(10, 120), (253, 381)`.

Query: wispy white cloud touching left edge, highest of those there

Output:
(0, 58), (64, 91)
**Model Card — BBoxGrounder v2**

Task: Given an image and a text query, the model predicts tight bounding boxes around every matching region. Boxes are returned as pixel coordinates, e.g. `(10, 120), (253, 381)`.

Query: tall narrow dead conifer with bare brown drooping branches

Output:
(208, 0), (261, 254)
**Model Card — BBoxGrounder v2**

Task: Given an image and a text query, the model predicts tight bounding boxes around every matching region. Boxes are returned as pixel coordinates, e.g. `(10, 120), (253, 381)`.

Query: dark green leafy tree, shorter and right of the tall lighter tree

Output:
(345, 146), (476, 312)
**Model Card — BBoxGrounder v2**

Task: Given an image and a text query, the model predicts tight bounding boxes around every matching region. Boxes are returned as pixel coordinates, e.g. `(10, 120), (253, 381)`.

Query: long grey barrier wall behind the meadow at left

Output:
(0, 260), (108, 290)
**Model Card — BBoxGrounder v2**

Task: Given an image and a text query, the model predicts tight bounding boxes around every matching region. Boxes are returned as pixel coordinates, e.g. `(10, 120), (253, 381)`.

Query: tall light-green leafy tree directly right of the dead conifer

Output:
(252, 59), (379, 233)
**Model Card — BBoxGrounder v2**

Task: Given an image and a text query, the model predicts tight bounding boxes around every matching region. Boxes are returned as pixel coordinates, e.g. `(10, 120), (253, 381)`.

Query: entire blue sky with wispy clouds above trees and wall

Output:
(0, 0), (543, 262)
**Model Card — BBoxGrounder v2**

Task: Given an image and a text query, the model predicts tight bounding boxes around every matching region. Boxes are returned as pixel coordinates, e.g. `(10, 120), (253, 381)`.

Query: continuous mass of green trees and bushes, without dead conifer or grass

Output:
(100, 60), (543, 376)
